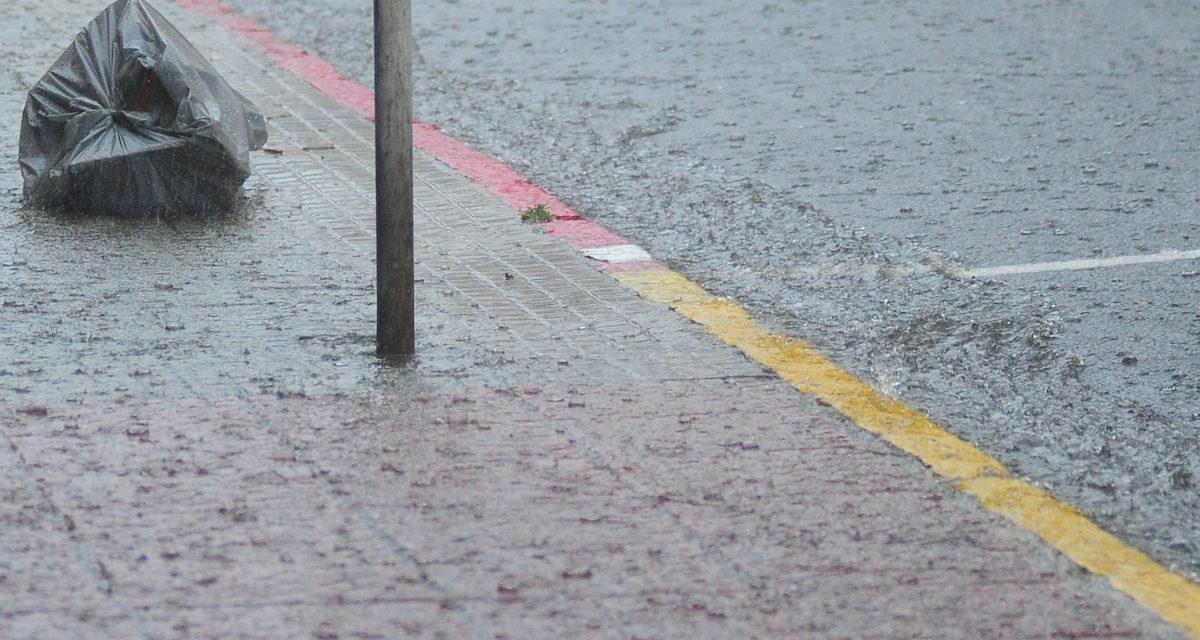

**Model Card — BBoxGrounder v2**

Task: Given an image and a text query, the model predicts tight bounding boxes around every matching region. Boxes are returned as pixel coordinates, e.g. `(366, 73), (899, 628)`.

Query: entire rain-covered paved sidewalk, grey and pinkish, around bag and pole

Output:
(0, 0), (1180, 639)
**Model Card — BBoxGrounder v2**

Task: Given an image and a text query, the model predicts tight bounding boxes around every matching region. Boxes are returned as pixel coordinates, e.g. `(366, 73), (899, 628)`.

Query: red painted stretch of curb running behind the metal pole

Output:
(175, 0), (662, 271)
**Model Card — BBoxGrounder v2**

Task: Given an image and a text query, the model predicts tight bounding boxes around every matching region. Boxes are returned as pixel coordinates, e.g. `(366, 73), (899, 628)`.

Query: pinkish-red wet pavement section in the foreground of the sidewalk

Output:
(2, 378), (1180, 638)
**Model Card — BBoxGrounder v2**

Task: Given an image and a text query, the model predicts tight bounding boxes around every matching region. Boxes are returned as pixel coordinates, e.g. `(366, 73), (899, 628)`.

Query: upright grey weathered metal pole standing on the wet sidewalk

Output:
(374, 0), (416, 355)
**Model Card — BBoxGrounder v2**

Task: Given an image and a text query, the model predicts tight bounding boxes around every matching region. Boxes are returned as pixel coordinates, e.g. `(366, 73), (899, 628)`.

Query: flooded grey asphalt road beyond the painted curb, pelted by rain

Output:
(220, 0), (1200, 579)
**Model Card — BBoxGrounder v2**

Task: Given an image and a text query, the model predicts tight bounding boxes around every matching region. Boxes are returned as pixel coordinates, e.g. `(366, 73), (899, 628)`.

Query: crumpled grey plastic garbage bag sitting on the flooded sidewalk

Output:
(19, 0), (266, 217)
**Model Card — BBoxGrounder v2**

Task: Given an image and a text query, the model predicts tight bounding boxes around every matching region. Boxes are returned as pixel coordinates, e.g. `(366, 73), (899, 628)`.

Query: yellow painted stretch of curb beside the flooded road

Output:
(613, 270), (1200, 638)
